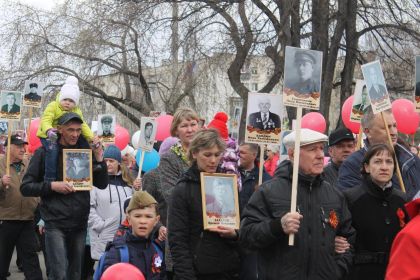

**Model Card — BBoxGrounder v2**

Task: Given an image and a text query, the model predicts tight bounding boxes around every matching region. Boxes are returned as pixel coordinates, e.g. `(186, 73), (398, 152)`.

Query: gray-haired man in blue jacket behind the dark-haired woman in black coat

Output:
(338, 108), (420, 200)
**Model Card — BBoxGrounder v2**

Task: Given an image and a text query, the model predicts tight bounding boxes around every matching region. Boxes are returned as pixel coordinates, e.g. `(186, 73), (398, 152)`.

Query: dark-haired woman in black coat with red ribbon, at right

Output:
(344, 144), (407, 280)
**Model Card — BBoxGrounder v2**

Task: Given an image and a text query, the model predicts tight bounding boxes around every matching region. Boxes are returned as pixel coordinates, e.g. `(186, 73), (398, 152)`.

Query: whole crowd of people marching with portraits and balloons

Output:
(0, 77), (420, 280)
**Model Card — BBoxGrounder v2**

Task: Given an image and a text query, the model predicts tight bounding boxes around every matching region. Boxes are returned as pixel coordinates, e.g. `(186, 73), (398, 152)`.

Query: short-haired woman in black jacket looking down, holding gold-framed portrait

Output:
(168, 129), (239, 280)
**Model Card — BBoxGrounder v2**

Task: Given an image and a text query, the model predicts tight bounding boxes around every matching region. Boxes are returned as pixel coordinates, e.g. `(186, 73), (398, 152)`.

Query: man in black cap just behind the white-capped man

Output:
(324, 127), (356, 187)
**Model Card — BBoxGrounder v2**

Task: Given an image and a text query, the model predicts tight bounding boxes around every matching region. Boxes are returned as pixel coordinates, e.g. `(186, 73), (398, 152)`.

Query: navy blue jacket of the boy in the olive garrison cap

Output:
(104, 230), (166, 280)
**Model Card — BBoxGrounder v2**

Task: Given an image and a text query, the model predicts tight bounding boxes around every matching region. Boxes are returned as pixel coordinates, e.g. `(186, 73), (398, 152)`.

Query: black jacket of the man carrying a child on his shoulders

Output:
(20, 136), (108, 230)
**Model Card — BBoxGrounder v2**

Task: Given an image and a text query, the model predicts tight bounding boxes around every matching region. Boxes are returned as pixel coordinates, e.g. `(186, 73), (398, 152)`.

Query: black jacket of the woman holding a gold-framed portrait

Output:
(168, 165), (239, 280)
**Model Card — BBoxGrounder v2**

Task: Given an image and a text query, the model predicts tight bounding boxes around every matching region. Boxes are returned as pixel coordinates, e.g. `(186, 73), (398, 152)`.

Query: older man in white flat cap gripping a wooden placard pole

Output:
(240, 129), (355, 280)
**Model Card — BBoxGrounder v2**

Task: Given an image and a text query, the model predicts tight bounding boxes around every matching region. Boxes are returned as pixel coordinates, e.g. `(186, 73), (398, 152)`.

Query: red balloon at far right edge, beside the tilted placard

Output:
(392, 98), (419, 134)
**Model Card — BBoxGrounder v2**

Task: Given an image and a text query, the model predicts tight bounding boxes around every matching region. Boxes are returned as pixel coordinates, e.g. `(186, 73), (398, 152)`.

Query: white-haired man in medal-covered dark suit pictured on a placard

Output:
(248, 97), (280, 130)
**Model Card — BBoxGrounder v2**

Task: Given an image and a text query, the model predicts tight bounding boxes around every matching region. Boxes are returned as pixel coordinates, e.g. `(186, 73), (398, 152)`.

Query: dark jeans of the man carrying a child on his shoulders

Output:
(45, 225), (86, 280)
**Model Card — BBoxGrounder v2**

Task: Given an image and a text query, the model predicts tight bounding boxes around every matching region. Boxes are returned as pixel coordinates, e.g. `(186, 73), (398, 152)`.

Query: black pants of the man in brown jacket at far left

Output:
(0, 220), (42, 280)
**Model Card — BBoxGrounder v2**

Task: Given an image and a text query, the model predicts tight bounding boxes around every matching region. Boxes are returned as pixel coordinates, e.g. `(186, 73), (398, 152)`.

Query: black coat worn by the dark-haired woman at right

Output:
(344, 175), (408, 280)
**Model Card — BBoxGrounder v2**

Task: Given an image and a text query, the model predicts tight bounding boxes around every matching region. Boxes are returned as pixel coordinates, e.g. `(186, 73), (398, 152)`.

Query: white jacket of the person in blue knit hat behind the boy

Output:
(88, 173), (133, 260)
